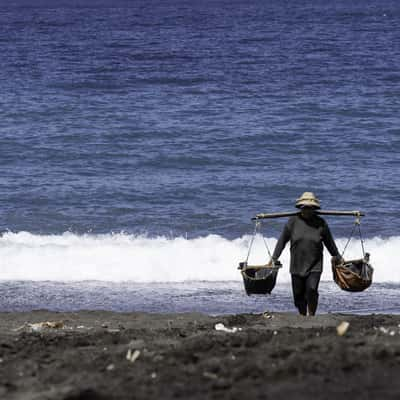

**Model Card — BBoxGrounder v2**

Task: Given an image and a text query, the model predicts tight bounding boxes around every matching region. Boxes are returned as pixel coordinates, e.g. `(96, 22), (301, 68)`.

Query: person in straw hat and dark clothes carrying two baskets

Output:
(270, 192), (341, 315)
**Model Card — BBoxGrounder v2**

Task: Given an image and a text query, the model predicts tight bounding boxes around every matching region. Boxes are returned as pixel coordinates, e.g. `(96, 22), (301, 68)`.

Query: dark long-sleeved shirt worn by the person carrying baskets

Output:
(272, 214), (339, 276)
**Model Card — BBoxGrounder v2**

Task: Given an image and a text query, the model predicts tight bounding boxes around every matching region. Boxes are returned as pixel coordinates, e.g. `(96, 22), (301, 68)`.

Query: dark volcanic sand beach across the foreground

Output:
(0, 311), (400, 400)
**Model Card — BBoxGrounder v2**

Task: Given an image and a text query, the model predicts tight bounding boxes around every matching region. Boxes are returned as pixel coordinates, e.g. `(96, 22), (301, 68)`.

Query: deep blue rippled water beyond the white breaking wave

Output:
(0, 0), (400, 238)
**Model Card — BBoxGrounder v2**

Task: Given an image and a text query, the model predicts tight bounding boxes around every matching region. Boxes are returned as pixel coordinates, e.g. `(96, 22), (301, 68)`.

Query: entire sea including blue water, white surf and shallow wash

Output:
(0, 0), (400, 314)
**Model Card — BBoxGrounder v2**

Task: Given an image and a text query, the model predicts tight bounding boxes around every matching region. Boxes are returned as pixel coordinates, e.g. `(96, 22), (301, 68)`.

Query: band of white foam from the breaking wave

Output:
(0, 232), (400, 282)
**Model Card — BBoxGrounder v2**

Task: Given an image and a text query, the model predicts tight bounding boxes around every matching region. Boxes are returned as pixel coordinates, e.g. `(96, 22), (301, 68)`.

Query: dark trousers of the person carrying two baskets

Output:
(292, 272), (321, 315)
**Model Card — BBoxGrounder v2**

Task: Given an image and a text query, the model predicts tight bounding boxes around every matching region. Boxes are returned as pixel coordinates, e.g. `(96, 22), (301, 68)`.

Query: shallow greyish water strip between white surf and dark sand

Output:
(0, 281), (400, 315)
